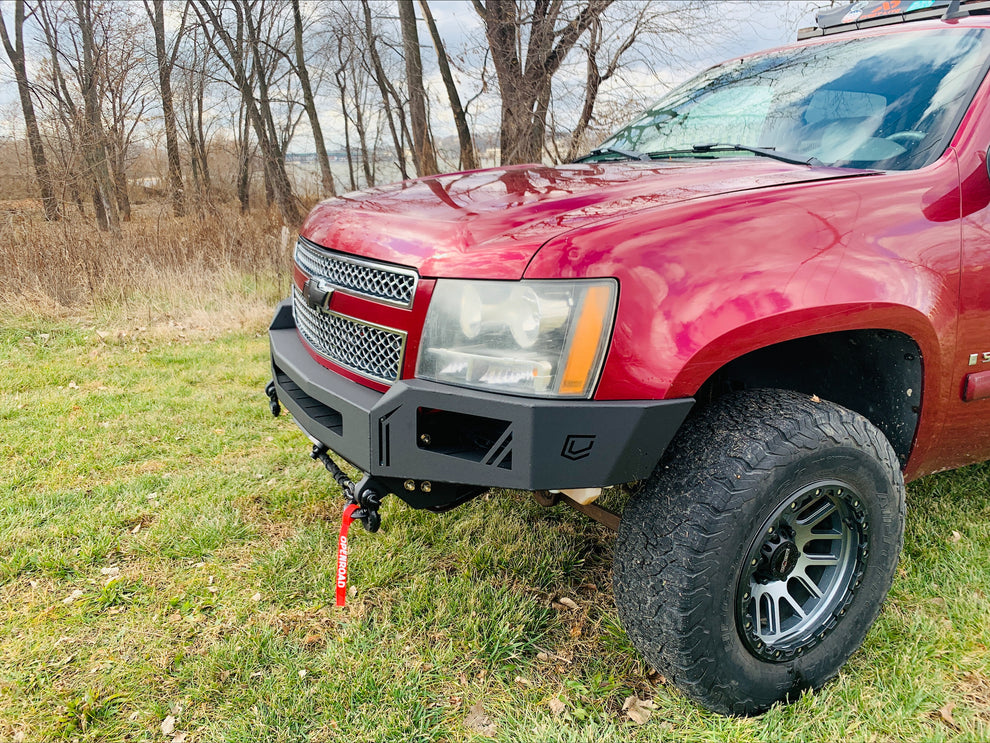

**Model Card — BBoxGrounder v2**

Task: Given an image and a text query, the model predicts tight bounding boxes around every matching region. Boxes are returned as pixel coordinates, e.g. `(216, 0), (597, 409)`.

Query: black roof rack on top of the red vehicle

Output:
(798, 0), (990, 41)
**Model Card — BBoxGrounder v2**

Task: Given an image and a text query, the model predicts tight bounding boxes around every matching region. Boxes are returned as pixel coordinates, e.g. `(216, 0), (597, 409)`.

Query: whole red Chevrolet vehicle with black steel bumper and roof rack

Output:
(268, 0), (990, 714)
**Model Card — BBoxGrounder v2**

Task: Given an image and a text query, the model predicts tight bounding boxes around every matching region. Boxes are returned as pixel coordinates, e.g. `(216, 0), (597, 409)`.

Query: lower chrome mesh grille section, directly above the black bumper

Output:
(292, 287), (406, 384)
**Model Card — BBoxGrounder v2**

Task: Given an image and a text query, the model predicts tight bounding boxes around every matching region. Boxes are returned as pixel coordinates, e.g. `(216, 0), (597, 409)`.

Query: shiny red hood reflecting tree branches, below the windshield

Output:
(300, 157), (868, 279)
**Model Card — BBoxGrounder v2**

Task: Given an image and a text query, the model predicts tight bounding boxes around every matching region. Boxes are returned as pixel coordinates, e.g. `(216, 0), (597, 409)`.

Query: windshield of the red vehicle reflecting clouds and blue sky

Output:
(591, 29), (987, 170)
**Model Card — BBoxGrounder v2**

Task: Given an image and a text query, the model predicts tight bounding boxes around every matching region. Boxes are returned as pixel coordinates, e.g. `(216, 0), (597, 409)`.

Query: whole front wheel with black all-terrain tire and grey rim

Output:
(613, 390), (905, 715)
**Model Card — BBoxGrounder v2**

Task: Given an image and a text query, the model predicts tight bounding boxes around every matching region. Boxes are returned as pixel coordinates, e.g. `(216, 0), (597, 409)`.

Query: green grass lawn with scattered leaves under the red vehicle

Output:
(0, 321), (990, 743)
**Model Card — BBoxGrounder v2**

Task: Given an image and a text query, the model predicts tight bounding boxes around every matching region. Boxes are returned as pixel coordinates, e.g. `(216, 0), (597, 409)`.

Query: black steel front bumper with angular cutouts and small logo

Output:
(269, 301), (694, 508)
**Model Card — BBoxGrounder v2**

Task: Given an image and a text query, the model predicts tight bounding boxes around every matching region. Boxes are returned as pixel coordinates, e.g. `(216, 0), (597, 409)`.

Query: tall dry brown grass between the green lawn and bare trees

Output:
(0, 200), (295, 334)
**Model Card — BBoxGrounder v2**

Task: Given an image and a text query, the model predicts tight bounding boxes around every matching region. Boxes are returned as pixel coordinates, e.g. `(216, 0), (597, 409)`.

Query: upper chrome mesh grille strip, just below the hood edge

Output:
(295, 238), (417, 307)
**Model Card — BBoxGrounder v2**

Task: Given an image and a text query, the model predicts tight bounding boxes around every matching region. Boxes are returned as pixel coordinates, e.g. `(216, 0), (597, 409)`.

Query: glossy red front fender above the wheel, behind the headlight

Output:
(526, 158), (960, 412)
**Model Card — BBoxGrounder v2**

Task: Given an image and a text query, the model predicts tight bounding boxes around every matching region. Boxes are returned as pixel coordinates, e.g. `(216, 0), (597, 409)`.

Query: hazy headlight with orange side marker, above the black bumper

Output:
(416, 279), (618, 397)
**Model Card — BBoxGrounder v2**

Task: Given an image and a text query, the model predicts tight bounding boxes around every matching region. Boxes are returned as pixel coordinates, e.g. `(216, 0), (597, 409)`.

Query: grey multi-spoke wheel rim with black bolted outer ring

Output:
(735, 480), (869, 662)
